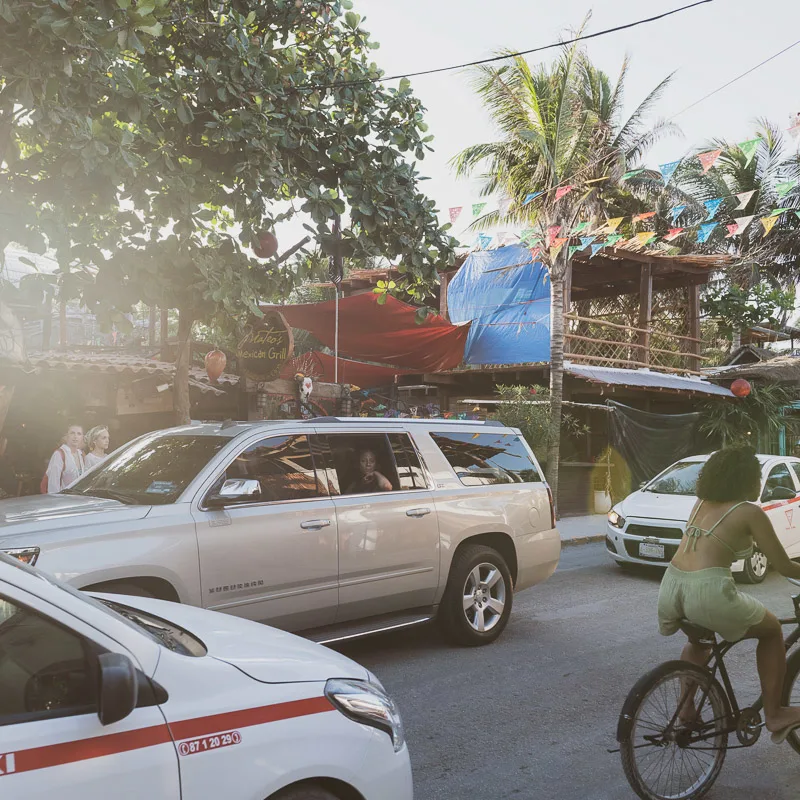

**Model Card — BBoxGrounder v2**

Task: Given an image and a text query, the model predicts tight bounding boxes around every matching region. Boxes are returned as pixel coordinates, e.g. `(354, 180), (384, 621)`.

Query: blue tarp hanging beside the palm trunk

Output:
(447, 245), (550, 364)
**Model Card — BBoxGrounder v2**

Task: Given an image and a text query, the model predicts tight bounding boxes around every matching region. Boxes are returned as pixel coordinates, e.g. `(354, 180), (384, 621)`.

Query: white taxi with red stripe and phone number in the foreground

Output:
(0, 555), (413, 800)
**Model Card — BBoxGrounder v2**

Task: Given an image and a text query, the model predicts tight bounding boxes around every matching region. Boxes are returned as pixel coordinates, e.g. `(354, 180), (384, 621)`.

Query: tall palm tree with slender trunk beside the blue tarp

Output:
(453, 37), (672, 510)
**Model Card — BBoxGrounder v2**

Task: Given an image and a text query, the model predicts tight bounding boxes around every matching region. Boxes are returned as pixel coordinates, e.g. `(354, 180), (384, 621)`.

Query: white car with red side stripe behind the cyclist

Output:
(606, 455), (800, 583)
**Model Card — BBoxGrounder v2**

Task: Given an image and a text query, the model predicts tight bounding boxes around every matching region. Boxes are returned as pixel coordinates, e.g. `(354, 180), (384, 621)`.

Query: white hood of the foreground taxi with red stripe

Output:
(97, 594), (369, 683)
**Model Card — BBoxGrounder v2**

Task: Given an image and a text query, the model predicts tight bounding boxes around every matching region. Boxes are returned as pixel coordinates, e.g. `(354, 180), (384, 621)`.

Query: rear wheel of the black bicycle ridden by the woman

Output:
(618, 661), (730, 800)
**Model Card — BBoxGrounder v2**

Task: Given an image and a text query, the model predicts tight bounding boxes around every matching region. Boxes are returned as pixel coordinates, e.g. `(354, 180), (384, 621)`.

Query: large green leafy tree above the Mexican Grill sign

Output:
(0, 0), (453, 421)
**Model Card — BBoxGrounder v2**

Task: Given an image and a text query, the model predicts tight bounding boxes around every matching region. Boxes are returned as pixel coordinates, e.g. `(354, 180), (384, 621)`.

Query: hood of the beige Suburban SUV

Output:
(0, 494), (151, 539)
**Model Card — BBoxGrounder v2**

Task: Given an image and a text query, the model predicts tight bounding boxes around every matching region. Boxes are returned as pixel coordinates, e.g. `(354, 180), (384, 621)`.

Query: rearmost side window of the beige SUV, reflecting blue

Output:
(431, 432), (542, 486)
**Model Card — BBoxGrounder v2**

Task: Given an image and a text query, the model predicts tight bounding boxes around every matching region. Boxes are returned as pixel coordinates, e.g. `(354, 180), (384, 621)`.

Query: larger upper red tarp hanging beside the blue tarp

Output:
(262, 292), (469, 372)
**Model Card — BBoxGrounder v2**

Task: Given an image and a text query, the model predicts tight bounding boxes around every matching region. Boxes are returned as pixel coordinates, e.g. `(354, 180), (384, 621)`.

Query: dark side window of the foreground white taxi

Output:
(0, 596), (97, 725)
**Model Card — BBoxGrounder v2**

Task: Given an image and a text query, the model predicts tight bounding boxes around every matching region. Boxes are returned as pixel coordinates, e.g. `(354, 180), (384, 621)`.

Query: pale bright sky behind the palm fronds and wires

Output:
(354, 0), (800, 241)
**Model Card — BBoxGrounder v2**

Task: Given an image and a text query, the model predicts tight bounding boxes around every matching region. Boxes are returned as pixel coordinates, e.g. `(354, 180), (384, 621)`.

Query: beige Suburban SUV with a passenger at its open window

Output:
(0, 418), (561, 644)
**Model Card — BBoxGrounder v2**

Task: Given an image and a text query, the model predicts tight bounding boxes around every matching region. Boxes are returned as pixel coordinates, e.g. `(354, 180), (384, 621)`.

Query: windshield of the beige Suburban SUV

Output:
(63, 433), (230, 505)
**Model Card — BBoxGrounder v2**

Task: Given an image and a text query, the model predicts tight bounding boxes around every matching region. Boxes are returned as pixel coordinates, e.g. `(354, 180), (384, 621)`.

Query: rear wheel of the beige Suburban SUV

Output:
(439, 545), (514, 647)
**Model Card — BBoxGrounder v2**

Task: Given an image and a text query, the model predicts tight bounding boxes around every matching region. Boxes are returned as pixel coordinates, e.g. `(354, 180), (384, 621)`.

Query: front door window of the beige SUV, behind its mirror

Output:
(219, 434), (327, 503)
